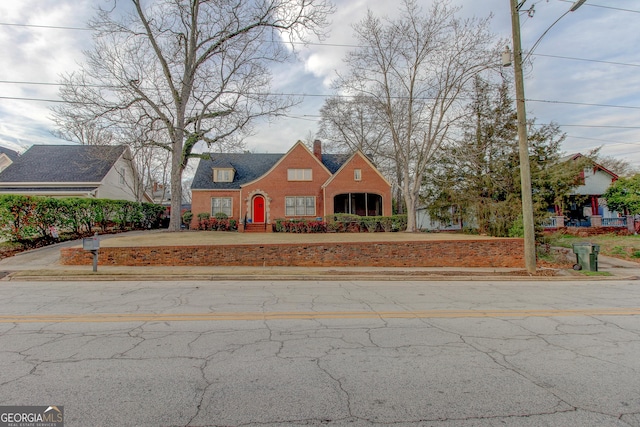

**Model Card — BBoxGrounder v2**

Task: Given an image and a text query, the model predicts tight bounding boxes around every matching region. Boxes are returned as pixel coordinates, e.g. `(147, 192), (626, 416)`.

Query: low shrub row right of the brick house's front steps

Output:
(273, 214), (407, 233)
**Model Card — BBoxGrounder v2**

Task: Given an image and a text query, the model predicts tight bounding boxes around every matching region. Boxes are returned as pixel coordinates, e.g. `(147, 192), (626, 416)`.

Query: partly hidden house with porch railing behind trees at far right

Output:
(555, 153), (622, 227)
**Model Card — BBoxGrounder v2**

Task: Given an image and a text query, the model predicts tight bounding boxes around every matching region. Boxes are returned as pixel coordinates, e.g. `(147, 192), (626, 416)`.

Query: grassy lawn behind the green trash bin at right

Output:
(548, 233), (640, 262)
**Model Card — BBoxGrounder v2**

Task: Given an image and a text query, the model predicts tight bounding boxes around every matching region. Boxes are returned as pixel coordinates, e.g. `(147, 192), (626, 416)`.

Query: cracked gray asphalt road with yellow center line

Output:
(0, 280), (640, 427)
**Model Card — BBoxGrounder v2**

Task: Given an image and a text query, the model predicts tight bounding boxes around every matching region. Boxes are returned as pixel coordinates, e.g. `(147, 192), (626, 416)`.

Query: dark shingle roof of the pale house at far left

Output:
(0, 145), (126, 185)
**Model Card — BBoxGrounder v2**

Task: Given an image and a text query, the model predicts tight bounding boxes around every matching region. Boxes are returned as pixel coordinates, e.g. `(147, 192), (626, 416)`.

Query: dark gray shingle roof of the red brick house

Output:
(191, 153), (350, 190)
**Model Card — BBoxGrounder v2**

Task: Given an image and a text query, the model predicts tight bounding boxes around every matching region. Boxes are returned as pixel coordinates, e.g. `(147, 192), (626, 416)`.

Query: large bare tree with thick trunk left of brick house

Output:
(53, 0), (333, 231)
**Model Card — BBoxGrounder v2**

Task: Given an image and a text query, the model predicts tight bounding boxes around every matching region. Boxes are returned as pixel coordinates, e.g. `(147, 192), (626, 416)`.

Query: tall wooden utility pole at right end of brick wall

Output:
(509, 0), (536, 274)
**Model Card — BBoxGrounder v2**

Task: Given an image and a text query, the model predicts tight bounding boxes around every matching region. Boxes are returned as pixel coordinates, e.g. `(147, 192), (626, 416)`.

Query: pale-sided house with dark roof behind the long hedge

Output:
(0, 145), (144, 201)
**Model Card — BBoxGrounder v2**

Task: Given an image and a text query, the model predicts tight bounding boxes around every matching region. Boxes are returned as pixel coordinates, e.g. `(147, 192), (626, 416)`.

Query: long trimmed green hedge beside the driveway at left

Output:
(0, 194), (165, 241)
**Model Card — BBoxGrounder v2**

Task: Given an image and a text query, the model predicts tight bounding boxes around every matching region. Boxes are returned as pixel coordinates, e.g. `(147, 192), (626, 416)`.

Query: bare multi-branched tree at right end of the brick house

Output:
(337, 0), (498, 231)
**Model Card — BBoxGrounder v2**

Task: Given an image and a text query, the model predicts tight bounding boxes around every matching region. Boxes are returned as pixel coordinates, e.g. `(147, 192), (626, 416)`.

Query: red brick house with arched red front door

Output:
(191, 141), (391, 231)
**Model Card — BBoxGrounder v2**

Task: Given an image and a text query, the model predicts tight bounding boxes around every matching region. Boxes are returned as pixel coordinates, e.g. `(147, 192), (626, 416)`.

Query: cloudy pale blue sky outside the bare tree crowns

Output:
(0, 0), (640, 168)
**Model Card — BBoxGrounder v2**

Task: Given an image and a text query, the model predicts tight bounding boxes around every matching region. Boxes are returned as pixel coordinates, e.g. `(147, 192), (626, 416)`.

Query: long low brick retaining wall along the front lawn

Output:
(60, 239), (524, 268)
